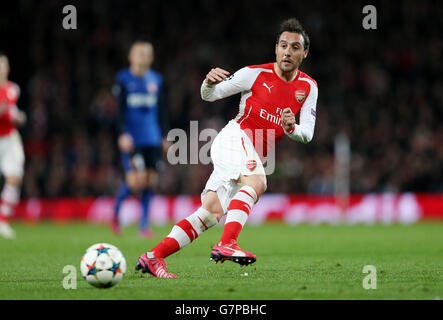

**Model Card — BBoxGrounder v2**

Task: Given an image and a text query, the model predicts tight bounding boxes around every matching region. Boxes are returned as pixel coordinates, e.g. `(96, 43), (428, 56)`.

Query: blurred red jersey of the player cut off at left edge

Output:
(0, 81), (20, 137)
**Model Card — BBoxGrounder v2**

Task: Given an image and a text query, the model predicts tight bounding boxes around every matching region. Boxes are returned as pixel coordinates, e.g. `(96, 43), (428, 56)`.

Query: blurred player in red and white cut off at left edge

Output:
(0, 52), (26, 238)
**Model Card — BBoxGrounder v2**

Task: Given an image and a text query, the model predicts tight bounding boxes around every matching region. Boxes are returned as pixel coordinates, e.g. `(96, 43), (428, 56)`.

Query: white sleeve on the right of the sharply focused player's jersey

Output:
(283, 84), (318, 143)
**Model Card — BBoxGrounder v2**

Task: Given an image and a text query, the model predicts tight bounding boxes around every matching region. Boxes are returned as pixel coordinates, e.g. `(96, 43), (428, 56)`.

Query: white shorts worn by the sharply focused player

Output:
(201, 120), (265, 213)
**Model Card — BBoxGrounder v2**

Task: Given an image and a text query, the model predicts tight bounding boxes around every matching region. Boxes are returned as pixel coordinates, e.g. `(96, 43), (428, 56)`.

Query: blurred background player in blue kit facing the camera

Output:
(111, 41), (169, 238)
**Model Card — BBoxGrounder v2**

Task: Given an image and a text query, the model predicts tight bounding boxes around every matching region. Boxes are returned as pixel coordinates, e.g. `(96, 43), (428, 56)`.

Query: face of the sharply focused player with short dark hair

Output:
(275, 31), (308, 72)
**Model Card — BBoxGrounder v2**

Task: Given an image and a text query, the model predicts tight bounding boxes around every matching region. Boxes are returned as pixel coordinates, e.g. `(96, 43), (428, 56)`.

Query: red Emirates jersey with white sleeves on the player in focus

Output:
(201, 63), (318, 156)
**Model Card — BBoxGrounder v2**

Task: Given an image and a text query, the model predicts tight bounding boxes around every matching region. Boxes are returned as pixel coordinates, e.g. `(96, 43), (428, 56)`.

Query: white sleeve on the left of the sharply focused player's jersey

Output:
(200, 67), (256, 102)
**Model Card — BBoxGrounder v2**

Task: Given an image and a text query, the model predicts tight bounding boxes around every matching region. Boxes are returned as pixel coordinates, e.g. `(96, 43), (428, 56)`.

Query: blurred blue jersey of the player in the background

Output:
(113, 69), (165, 147)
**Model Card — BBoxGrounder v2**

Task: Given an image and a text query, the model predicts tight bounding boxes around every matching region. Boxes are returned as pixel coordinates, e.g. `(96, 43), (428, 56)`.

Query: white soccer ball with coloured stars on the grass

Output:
(80, 243), (126, 288)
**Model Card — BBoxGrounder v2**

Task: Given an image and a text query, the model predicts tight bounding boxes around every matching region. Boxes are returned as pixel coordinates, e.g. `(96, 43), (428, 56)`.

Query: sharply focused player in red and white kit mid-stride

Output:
(136, 19), (318, 278)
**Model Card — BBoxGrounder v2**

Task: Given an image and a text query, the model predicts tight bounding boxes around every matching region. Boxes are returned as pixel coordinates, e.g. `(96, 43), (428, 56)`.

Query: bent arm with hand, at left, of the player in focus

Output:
(200, 67), (252, 102)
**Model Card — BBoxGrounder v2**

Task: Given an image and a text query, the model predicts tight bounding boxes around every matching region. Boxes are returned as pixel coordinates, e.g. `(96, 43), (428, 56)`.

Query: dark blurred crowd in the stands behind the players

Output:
(0, 0), (443, 198)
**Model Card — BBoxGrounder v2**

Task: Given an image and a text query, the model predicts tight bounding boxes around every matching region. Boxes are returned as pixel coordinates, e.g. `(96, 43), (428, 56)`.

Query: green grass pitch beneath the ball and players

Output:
(0, 222), (443, 300)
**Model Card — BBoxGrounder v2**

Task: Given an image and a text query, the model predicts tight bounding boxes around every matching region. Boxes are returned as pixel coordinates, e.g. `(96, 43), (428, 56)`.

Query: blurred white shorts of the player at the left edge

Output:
(0, 130), (25, 178)
